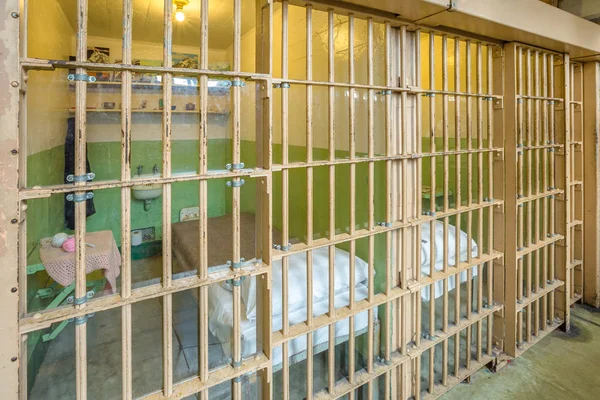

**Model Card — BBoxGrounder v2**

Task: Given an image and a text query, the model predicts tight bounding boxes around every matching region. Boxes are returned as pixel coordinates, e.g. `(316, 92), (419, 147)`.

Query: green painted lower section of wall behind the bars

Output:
(28, 139), (487, 296)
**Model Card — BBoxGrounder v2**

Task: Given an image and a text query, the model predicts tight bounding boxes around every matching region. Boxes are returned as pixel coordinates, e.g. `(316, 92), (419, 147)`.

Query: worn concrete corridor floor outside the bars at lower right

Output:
(442, 306), (600, 400)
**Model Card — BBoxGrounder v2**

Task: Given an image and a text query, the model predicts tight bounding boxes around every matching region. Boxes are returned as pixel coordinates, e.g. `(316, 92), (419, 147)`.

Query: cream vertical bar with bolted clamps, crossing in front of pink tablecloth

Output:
(75, 0), (88, 400)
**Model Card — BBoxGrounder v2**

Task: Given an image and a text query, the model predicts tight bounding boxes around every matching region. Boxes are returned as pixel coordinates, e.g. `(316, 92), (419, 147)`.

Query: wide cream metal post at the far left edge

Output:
(0, 0), (20, 398)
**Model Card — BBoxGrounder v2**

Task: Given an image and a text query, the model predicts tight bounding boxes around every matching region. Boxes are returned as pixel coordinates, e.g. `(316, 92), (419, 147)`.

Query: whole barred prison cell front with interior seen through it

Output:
(3, 0), (583, 399)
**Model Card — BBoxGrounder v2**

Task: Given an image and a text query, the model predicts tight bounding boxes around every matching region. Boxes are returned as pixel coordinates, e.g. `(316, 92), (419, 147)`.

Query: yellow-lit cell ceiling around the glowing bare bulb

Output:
(56, 0), (255, 49)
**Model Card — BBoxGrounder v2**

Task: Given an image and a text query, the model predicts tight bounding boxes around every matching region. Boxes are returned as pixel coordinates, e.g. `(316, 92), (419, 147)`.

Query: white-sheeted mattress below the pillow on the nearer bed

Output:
(208, 284), (377, 366)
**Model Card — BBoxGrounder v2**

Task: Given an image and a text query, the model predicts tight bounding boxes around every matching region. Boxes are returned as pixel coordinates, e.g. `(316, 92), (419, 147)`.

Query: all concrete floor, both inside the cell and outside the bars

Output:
(29, 257), (600, 400)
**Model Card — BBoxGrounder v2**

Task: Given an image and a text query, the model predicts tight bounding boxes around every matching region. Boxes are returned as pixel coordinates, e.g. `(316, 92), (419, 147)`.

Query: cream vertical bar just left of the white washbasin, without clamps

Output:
(121, 0), (133, 400)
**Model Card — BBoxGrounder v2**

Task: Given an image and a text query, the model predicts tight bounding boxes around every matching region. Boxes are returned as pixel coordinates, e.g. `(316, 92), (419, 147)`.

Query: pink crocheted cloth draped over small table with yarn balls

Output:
(40, 231), (121, 293)
